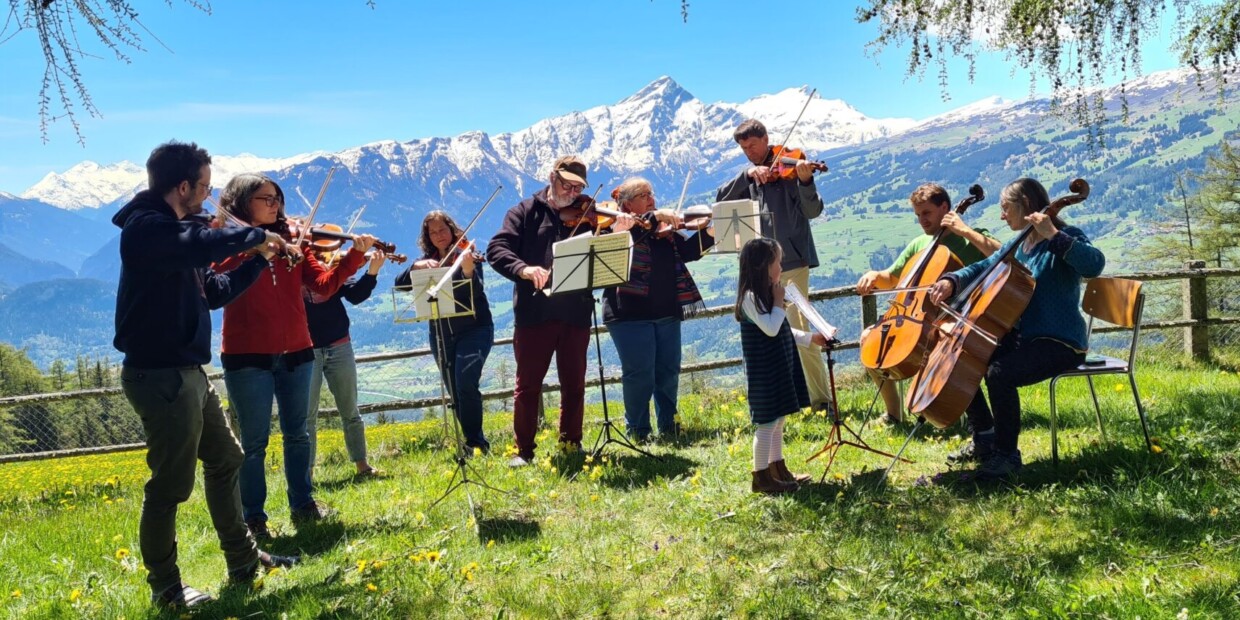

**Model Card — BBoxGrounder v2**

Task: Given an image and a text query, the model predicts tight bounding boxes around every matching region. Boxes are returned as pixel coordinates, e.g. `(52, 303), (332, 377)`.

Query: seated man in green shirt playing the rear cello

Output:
(857, 184), (999, 423)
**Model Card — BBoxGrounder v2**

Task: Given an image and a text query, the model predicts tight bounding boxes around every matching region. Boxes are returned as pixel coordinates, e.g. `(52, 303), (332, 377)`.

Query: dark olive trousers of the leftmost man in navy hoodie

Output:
(120, 367), (258, 593)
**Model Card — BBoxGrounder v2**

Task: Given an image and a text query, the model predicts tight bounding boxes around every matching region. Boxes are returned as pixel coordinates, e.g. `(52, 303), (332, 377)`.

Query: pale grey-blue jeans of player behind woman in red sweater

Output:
(306, 341), (366, 466)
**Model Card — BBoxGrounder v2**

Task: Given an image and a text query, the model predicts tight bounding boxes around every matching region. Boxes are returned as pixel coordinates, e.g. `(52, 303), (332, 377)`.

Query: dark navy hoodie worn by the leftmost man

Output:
(112, 190), (268, 368)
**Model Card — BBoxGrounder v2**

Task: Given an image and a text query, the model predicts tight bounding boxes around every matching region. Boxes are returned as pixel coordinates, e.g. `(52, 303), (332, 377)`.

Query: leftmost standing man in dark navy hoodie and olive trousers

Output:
(112, 141), (296, 608)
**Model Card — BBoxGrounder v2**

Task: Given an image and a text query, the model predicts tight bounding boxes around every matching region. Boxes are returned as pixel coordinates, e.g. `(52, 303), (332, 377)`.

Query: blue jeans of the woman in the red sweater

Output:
(224, 355), (314, 521)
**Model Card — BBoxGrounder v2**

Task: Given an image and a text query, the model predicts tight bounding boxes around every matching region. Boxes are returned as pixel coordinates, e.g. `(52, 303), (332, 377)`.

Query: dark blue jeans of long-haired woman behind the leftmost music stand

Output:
(430, 324), (495, 450)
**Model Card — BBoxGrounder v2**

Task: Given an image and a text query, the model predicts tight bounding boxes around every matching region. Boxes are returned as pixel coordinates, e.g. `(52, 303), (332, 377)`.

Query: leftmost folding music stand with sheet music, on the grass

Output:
(392, 267), (510, 523)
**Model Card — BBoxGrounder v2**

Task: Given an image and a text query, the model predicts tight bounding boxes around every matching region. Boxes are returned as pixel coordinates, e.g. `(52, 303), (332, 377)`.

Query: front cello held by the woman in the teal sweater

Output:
(906, 179), (1089, 428)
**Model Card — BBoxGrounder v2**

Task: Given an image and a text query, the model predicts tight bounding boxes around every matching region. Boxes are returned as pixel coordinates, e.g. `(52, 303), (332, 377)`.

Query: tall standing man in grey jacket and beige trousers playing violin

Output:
(714, 119), (831, 409)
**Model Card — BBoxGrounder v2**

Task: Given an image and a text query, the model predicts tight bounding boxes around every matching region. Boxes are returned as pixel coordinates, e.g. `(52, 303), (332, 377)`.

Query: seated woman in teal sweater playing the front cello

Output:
(930, 179), (1106, 480)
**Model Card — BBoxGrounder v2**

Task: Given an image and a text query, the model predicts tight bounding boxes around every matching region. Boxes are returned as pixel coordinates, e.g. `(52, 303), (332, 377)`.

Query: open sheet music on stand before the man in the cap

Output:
(551, 231), (632, 293)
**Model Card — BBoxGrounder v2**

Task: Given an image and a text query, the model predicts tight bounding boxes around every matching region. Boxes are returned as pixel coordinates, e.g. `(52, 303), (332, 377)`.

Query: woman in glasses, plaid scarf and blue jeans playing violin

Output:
(603, 177), (714, 441)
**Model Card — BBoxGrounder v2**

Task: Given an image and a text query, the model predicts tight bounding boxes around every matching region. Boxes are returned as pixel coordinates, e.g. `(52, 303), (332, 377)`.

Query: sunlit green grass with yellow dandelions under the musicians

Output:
(0, 353), (1240, 619)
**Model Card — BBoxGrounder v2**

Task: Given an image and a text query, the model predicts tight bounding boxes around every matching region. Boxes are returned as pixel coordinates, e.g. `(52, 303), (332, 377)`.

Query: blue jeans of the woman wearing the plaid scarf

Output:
(608, 317), (681, 439)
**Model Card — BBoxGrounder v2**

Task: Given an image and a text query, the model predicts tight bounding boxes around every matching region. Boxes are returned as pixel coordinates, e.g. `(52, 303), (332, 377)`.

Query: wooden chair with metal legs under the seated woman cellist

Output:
(1050, 278), (1153, 465)
